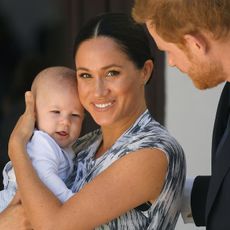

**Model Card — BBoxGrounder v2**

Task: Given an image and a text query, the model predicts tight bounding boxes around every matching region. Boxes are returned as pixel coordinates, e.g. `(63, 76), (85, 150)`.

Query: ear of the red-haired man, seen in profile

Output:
(184, 34), (208, 54)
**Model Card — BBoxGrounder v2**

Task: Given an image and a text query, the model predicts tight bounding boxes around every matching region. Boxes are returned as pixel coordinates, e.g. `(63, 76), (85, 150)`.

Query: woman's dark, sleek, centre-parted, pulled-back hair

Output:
(74, 13), (152, 68)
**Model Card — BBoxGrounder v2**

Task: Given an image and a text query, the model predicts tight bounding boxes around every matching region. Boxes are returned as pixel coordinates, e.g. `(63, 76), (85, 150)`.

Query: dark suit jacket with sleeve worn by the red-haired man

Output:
(191, 82), (230, 230)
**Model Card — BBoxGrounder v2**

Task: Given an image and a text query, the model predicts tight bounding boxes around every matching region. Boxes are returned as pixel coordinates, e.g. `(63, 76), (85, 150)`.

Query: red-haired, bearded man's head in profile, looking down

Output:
(133, 0), (230, 89)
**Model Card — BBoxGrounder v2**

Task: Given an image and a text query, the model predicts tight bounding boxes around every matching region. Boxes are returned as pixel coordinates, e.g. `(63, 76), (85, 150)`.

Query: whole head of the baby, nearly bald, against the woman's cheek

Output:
(31, 67), (84, 148)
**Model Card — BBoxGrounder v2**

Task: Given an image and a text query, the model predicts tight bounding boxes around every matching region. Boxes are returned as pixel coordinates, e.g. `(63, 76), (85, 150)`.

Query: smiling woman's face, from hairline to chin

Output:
(75, 37), (149, 126)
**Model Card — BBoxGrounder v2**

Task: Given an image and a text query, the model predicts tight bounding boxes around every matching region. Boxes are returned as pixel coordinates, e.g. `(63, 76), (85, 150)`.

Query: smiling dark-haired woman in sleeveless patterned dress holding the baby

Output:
(0, 14), (185, 230)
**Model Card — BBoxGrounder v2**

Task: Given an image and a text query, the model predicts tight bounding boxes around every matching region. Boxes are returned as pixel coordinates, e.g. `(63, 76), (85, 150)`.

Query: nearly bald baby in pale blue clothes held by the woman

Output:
(0, 67), (84, 212)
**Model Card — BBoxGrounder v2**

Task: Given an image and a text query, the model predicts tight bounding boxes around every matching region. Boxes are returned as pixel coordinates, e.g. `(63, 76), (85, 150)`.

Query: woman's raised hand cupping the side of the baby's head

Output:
(8, 91), (35, 157)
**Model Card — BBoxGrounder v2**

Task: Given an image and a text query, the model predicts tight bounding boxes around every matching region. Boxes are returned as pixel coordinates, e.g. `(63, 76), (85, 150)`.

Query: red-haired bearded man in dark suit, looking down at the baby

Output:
(132, 0), (230, 230)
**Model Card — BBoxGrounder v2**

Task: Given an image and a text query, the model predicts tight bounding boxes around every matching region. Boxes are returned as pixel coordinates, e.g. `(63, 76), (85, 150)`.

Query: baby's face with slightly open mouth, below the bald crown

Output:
(36, 82), (84, 148)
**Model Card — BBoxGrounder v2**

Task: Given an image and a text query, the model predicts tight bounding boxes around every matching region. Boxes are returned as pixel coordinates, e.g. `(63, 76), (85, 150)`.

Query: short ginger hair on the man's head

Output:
(132, 0), (230, 43)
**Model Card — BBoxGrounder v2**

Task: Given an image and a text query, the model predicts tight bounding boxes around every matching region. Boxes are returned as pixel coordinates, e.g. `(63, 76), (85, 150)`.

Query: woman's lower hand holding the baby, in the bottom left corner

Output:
(0, 194), (33, 230)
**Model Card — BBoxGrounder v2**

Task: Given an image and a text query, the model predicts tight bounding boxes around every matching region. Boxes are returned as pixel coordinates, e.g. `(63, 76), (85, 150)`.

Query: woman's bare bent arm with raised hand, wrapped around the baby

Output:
(9, 92), (168, 230)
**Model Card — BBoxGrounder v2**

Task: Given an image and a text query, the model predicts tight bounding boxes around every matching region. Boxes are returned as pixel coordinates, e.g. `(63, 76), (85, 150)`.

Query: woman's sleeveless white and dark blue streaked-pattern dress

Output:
(66, 110), (186, 230)
